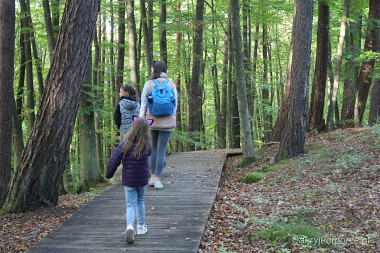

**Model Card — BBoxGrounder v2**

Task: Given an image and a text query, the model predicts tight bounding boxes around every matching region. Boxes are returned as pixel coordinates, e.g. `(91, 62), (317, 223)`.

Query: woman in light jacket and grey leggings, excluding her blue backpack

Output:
(139, 61), (178, 189)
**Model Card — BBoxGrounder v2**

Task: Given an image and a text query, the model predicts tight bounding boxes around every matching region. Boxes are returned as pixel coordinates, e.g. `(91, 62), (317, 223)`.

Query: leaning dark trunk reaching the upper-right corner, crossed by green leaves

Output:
(355, 0), (380, 125)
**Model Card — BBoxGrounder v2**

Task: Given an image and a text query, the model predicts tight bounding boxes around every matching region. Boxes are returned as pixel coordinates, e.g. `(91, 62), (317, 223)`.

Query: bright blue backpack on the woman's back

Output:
(147, 79), (175, 116)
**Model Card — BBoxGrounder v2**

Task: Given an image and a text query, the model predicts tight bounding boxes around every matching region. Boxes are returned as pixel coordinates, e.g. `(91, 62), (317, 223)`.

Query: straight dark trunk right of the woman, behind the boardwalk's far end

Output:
(188, 0), (205, 151)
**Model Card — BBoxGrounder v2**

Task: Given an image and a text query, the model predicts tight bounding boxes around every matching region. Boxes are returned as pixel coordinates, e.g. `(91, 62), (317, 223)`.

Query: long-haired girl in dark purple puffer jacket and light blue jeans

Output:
(106, 118), (152, 243)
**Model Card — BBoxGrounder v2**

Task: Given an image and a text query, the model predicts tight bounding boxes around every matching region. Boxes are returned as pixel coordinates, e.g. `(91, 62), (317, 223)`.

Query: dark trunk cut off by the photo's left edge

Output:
(0, 0), (16, 204)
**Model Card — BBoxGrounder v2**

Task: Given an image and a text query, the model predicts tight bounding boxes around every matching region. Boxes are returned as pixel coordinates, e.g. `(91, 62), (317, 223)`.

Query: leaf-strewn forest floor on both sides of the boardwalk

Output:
(0, 125), (380, 252)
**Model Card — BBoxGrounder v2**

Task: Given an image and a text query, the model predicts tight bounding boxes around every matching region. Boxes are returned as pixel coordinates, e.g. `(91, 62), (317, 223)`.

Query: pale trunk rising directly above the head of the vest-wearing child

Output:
(127, 0), (139, 87)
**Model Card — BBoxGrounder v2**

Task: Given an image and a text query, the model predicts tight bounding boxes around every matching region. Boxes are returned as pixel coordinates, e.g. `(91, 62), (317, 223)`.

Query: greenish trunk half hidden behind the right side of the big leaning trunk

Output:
(77, 55), (101, 193)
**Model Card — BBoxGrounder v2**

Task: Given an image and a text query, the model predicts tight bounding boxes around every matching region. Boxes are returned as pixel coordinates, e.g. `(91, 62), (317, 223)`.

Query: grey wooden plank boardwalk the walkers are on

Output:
(27, 150), (240, 253)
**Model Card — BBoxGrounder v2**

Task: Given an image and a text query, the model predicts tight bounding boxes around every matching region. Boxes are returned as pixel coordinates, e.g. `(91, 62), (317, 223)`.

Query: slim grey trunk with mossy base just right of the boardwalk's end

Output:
(230, 0), (255, 164)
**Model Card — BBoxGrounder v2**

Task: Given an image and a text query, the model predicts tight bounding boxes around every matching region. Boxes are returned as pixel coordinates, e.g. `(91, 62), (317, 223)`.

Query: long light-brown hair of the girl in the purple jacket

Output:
(123, 118), (152, 159)
